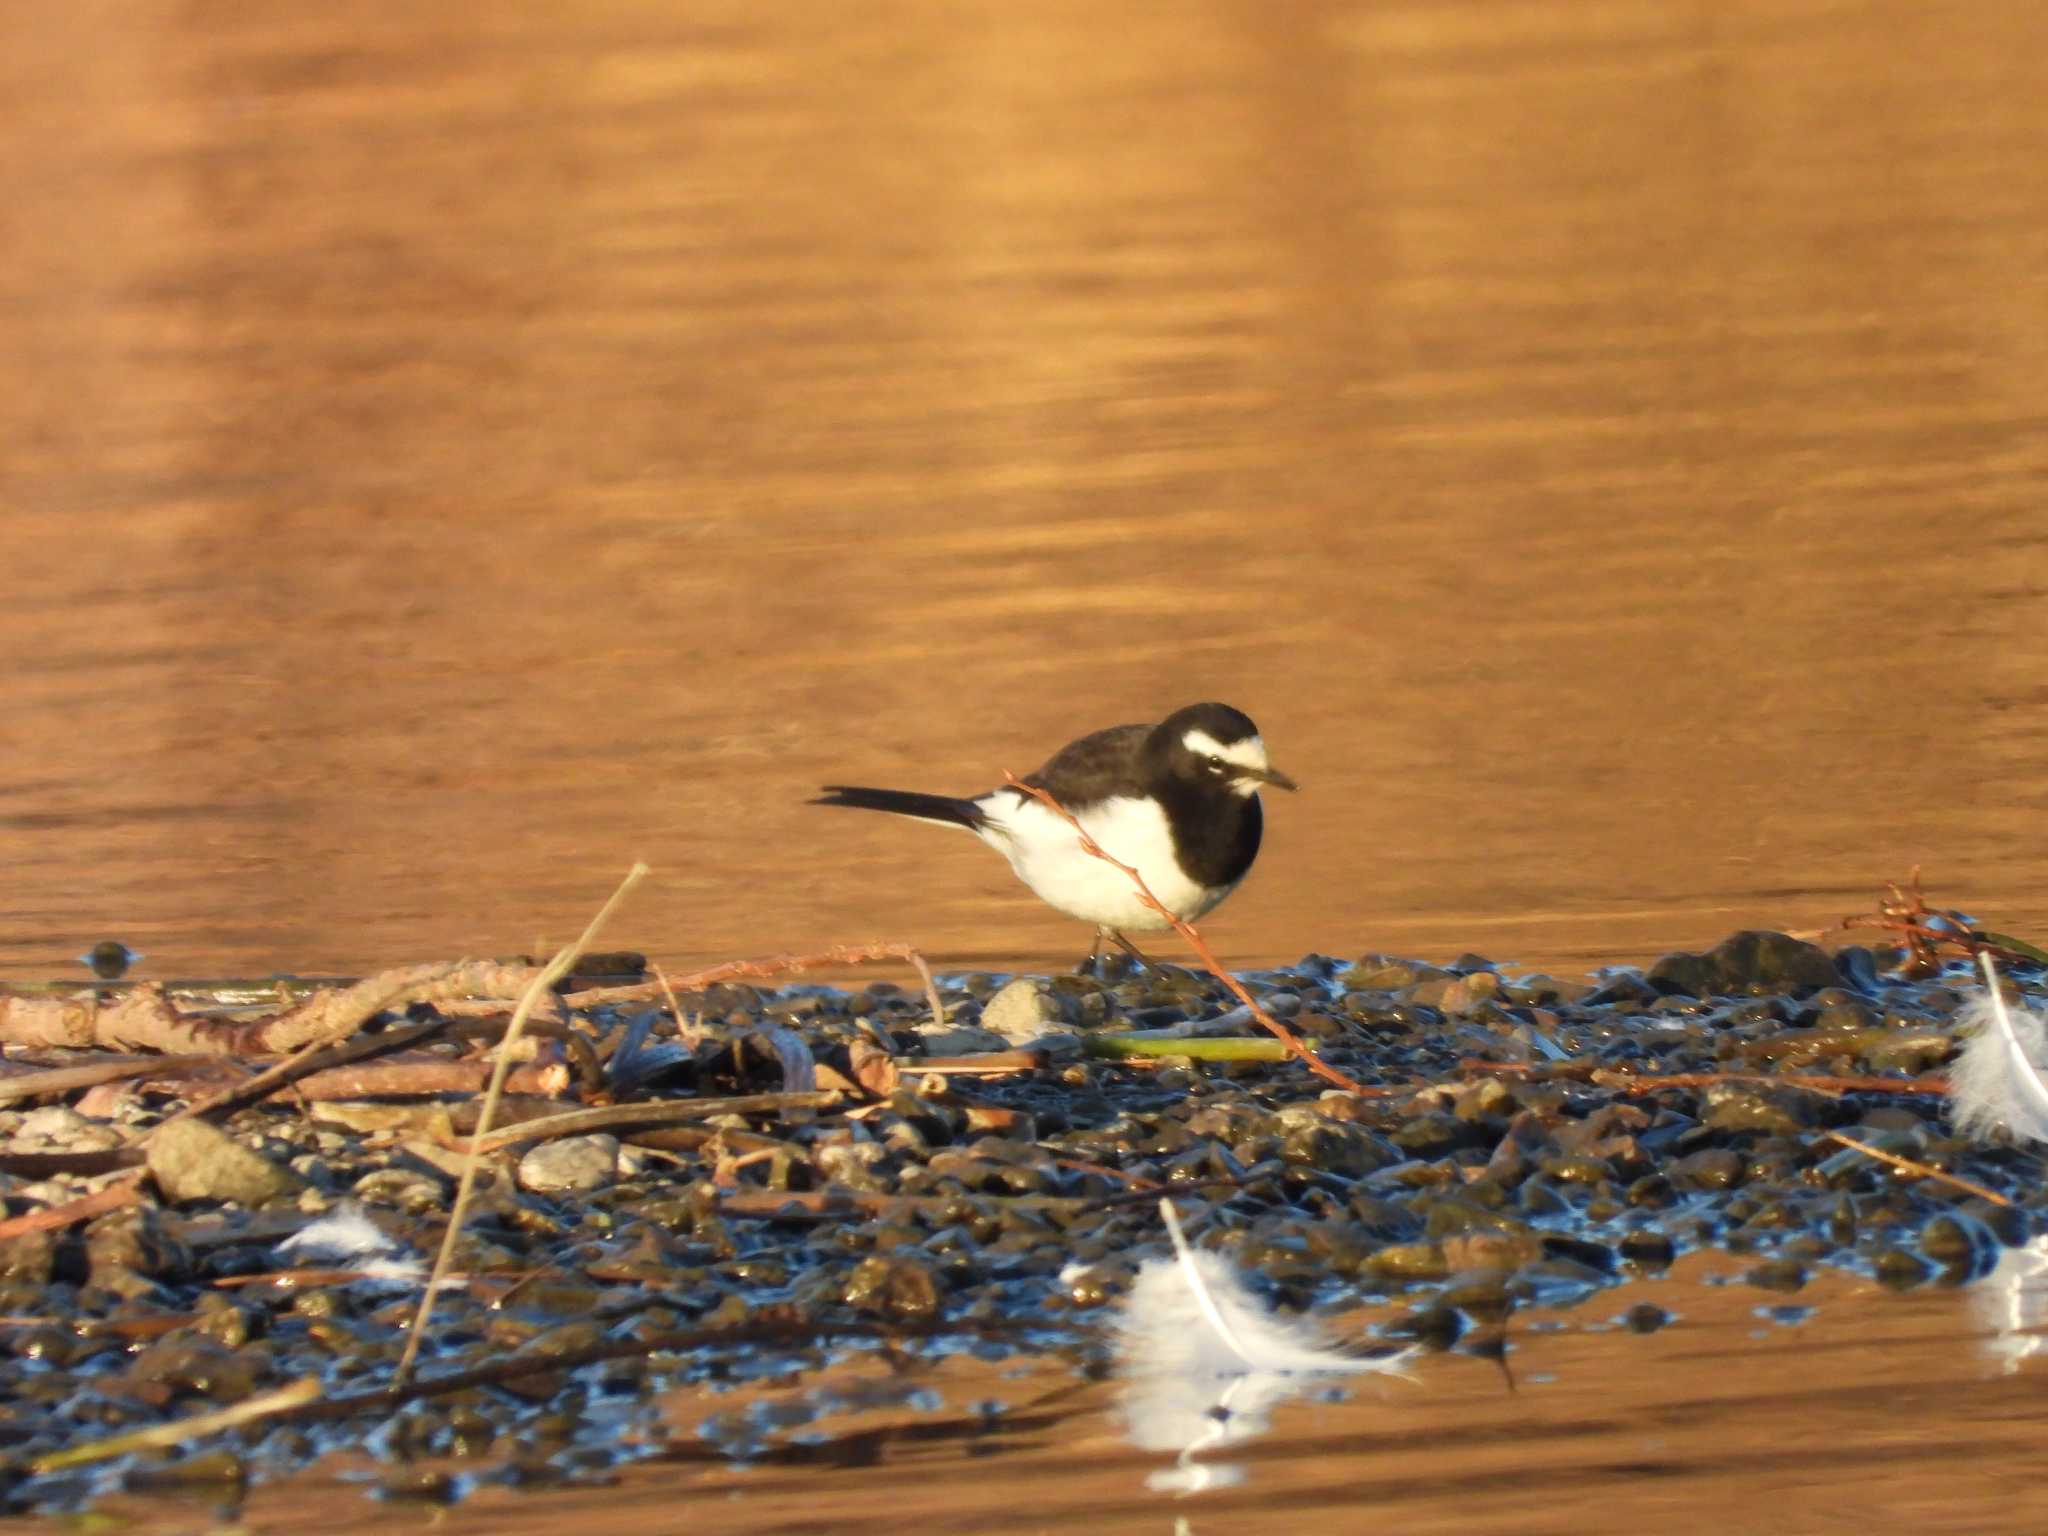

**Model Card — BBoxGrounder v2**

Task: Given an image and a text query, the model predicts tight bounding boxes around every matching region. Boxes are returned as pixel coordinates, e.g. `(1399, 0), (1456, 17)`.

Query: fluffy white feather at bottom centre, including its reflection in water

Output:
(1118, 1200), (1409, 1493)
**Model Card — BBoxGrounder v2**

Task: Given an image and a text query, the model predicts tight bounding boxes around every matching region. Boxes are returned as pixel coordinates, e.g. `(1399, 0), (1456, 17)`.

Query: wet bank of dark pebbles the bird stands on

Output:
(0, 934), (2048, 1513)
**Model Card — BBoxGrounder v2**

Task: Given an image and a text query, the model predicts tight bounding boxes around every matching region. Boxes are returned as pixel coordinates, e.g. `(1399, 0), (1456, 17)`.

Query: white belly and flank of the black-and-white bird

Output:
(979, 793), (1231, 934)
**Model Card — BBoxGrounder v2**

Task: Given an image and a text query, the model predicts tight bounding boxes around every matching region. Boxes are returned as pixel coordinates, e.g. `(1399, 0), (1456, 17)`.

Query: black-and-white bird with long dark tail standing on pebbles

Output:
(811, 702), (1298, 967)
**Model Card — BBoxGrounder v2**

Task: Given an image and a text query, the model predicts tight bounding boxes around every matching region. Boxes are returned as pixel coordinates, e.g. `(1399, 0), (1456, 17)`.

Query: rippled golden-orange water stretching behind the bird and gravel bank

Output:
(0, 0), (2048, 975)
